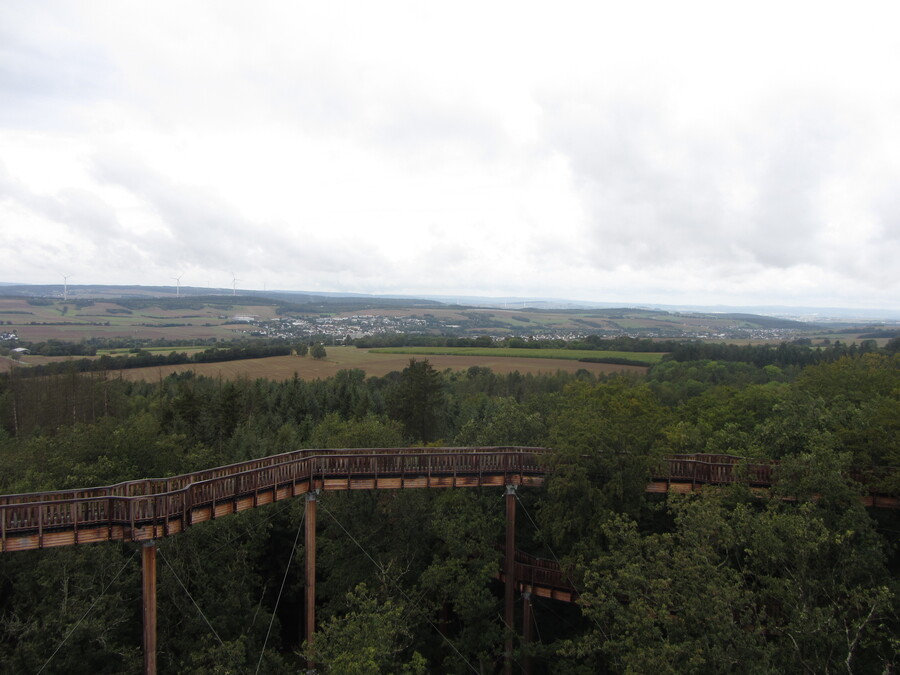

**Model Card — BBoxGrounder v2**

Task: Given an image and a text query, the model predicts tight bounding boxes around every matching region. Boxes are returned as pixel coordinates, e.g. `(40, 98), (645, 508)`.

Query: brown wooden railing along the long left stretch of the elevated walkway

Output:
(0, 447), (546, 551)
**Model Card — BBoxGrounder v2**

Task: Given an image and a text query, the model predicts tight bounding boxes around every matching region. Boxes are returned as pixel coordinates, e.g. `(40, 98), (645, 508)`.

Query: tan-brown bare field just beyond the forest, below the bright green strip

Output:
(109, 347), (647, 380)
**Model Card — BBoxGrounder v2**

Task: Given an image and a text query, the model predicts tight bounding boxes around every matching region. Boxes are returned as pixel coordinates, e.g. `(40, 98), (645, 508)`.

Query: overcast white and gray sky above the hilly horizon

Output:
(0, 0), (900, 309)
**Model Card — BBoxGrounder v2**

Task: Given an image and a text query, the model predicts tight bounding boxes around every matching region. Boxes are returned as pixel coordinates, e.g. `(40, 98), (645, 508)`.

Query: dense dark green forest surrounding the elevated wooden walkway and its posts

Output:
(0, 344), (900, 674)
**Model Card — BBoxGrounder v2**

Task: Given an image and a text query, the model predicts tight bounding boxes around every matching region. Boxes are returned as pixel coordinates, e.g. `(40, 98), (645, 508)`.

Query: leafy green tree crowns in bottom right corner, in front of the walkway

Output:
(561, 496), (897, 673)
